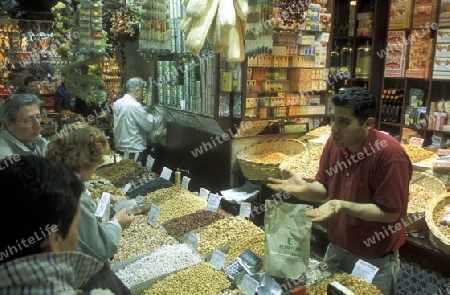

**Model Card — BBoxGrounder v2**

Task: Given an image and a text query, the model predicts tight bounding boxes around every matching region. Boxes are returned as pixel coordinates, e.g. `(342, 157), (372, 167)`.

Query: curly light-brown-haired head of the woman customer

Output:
(46, 123), (109, 181)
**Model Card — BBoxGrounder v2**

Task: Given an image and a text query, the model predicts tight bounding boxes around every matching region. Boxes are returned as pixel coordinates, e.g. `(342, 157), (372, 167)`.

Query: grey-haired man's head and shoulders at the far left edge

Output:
(0, 93), (47, 158)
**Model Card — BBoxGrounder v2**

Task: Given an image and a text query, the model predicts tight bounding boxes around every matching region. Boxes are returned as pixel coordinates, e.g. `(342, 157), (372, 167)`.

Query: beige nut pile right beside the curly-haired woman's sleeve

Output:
(111, 215), (178, 264)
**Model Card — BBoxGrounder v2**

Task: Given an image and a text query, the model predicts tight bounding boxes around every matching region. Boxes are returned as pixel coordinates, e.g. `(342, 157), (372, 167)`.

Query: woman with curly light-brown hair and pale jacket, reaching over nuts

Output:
(46, 124), (134, 262)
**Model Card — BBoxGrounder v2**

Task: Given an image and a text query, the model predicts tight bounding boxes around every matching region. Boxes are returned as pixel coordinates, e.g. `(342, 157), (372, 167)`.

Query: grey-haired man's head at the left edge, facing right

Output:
(0, 93), (41, 142)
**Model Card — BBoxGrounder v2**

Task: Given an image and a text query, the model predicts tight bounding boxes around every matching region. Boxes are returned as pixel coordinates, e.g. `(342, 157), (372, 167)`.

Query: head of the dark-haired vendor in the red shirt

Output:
(330, 87), (376, 148)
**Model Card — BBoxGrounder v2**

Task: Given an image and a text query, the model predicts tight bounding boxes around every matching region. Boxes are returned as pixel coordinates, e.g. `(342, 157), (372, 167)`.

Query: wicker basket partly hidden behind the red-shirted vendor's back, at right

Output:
(406, 171), (446, 233)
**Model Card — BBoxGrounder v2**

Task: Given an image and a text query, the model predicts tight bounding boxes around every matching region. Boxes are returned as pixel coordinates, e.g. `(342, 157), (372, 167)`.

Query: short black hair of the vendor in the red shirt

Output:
(331, 87), (376, 124)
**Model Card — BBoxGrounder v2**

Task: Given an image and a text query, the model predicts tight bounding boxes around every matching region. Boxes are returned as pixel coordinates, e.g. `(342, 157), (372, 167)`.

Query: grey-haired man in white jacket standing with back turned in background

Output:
(113, 78), (162, 165)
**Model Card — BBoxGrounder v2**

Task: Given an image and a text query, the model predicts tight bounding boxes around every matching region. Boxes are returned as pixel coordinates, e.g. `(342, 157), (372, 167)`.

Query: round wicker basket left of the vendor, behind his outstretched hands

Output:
(237, 139), (306, 181)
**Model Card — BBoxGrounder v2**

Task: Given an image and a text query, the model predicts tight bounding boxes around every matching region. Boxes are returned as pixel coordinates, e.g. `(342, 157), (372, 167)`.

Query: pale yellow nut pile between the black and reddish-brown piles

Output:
(158, 193), (206, 223)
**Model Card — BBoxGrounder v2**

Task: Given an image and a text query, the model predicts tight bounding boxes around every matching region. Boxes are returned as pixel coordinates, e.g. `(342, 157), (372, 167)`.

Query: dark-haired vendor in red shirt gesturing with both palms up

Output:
(268, 87), (412, 295)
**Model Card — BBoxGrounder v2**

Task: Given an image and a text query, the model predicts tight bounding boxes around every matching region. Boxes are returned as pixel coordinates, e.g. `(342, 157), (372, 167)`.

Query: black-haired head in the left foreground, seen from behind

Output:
(0, 155), (84, 264)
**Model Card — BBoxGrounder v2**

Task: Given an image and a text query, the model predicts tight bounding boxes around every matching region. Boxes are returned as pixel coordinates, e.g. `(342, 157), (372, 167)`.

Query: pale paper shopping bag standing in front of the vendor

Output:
(263, 200), (313, 279)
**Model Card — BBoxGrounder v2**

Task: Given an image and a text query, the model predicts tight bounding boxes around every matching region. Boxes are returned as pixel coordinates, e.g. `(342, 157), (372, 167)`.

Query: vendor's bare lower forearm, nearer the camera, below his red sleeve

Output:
(340, 201), (399, 223)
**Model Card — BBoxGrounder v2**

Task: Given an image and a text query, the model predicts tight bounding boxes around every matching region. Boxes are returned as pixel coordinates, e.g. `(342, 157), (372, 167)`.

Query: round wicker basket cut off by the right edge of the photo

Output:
(425, 193), (450, 254)
